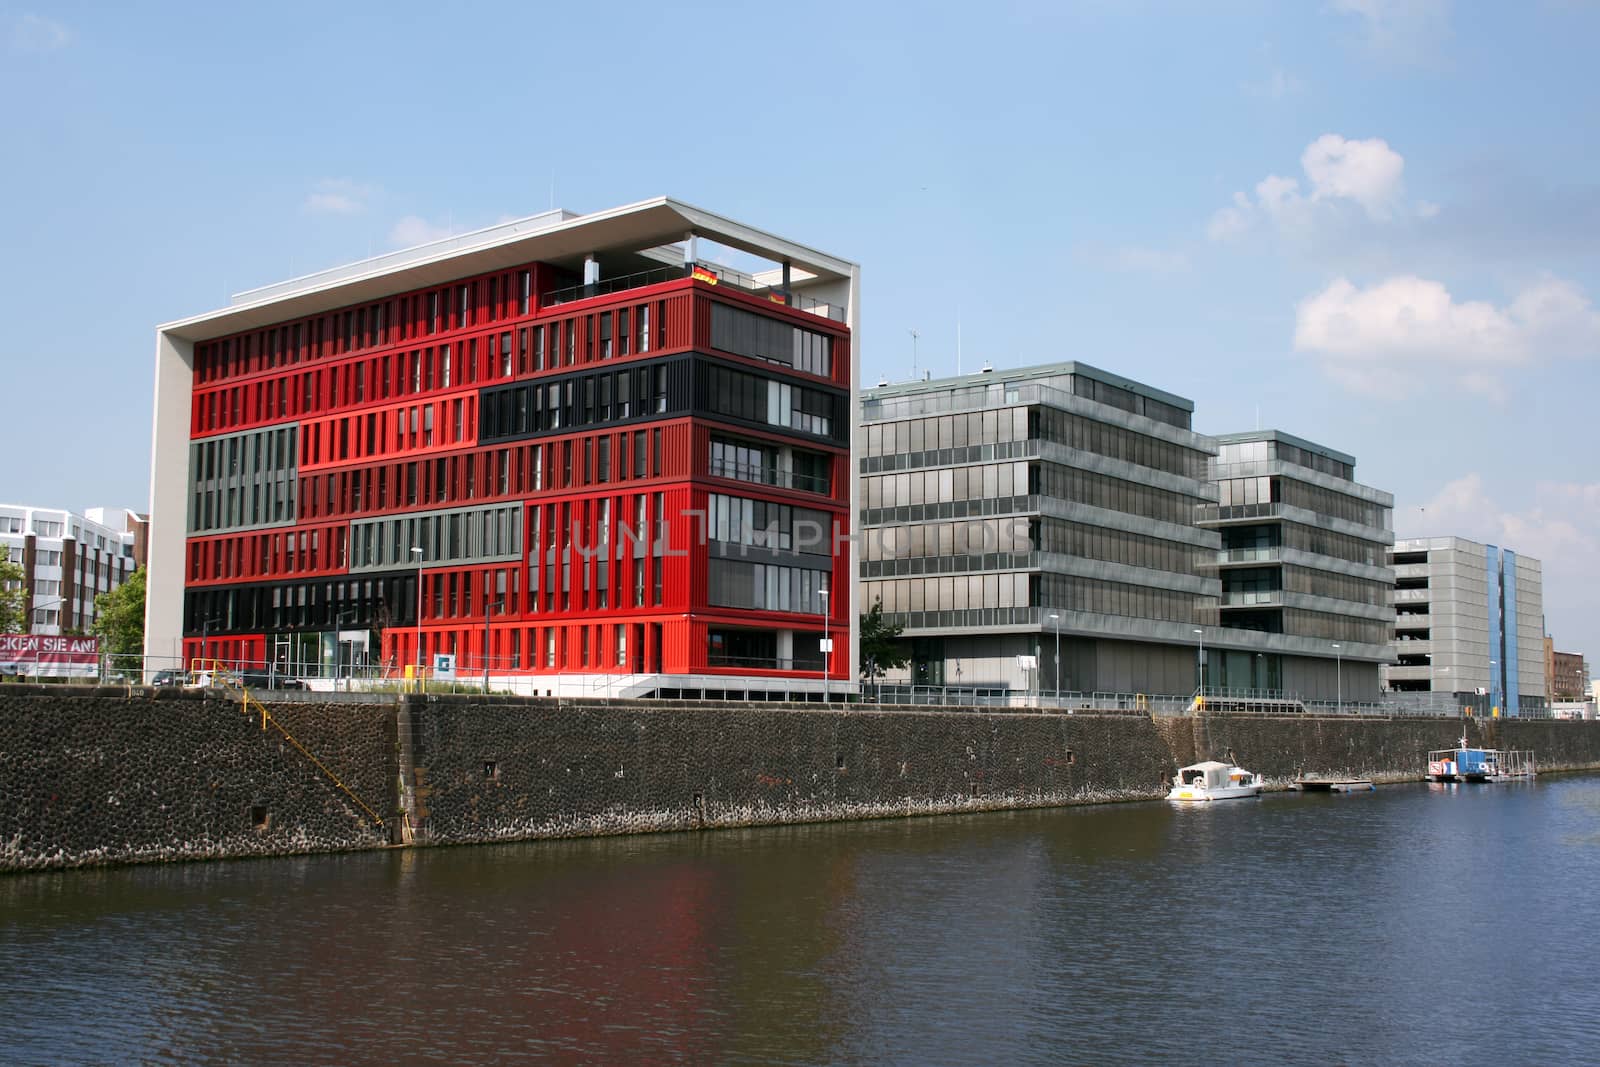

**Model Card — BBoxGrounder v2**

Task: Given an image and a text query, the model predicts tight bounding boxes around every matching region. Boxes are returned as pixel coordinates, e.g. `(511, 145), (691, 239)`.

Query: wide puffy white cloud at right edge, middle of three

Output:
(1294, 275), (1600, 395)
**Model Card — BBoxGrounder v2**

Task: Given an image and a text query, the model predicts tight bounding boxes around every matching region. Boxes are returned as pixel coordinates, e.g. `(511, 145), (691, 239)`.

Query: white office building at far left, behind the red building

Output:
(0, 504), (142, 635)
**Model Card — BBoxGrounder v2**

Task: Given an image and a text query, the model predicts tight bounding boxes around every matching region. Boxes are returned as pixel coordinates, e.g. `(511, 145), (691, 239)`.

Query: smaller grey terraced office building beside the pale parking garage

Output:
(1198, 430), (1394, 701)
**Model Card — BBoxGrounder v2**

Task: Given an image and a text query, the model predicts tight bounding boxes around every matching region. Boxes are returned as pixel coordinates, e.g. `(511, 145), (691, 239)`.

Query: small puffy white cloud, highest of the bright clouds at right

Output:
(1206, 133), (1414, 240)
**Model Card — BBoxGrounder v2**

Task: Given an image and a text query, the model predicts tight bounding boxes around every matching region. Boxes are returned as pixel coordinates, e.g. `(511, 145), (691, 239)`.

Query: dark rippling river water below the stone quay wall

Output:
(0, 776), (1600, 1067)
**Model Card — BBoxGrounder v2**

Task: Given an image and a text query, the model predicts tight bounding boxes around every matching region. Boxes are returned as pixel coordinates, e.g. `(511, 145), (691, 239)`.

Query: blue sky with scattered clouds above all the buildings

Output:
(0, 0), (1600, 656)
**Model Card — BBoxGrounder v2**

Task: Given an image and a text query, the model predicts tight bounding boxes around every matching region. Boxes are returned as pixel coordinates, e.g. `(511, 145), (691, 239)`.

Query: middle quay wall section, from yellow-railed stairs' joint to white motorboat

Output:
(402, 697), (1171, 843)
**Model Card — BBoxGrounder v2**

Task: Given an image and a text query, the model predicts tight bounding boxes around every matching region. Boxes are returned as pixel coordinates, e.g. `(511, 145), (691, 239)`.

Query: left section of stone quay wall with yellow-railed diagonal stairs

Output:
(0, 685), (394, 870)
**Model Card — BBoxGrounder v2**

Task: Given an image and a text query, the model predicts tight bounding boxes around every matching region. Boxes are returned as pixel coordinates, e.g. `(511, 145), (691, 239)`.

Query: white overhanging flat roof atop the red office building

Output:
(157, 197), (856, 341)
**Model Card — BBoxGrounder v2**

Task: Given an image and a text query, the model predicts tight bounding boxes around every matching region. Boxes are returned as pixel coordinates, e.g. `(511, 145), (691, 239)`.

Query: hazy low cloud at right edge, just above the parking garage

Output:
(1395, 474), (1600, 656)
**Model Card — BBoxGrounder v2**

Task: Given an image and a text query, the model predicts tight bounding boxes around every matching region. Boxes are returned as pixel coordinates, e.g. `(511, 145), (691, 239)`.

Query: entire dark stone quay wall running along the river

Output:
(0, 685), (1600, 870)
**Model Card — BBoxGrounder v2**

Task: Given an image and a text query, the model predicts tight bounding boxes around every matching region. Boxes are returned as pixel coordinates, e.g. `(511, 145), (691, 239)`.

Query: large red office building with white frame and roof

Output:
(146, 198), (859, 696)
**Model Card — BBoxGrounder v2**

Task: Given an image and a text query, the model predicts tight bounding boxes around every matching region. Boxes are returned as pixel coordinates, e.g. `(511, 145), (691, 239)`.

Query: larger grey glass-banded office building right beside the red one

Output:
(858, 363), (1229, 694)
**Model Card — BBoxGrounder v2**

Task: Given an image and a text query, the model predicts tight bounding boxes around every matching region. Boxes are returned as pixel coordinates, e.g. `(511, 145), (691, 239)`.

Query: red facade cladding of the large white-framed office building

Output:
(186, 264), (851, 677)
